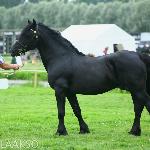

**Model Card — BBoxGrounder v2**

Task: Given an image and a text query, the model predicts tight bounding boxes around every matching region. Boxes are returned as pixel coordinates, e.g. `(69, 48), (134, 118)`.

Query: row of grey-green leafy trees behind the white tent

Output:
(0, 0), (150, 33)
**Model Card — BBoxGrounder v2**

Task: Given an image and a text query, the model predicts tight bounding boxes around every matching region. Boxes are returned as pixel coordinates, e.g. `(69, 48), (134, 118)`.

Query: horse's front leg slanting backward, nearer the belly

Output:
(67, 93), (90, 134)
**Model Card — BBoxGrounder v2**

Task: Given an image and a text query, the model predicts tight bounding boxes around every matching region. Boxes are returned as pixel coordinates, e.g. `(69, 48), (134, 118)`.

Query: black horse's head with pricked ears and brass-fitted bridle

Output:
(11, 19), (39, 56)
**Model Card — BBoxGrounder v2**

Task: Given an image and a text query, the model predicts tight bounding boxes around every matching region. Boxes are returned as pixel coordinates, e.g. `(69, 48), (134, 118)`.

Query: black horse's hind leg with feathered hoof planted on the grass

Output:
(129, 91), (150, 136)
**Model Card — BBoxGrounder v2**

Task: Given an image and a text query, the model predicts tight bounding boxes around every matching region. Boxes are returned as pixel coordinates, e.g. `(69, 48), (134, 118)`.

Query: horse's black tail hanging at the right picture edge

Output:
(138, 53), (150, 113)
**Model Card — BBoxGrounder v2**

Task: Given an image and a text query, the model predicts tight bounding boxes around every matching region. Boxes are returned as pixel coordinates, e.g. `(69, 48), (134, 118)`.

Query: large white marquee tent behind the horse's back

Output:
(61, 24), (136, 56)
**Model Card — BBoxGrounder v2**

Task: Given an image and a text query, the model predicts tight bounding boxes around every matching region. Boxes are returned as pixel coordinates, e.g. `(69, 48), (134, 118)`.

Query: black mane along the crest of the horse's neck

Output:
(38, 23), (85, 56)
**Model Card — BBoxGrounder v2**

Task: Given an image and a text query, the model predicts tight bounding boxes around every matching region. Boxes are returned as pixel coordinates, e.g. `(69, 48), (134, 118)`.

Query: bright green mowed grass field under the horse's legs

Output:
(0, 86), (150, 150)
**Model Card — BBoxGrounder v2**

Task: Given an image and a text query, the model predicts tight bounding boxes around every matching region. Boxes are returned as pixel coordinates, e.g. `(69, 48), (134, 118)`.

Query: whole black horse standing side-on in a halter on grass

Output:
(12, 20), (150, 136)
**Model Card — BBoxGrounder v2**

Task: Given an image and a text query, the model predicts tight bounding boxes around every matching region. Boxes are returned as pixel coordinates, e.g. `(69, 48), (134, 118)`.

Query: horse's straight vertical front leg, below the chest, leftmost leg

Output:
(55, 86), (68, 135)
